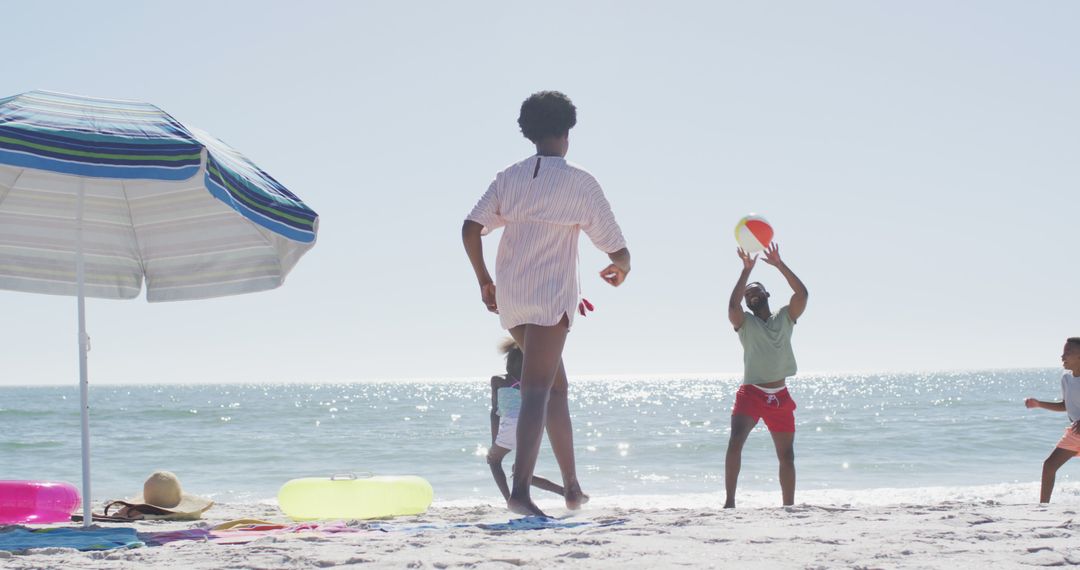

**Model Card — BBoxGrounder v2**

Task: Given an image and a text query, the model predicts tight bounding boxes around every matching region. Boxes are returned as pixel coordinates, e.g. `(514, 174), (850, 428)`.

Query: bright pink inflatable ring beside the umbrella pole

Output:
(0, 480), (82, 525)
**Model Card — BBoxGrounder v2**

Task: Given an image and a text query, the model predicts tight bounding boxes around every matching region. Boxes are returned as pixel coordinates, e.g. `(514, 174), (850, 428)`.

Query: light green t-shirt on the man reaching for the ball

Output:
(739, 307), (797, 384)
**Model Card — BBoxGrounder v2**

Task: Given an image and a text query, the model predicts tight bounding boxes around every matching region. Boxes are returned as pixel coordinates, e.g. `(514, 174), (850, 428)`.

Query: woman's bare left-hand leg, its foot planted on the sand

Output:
(507, 317), (572, 516)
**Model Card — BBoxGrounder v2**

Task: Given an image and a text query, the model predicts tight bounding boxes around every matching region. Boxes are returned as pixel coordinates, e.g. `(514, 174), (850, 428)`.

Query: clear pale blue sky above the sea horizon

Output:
(0, 1), (1080, 384)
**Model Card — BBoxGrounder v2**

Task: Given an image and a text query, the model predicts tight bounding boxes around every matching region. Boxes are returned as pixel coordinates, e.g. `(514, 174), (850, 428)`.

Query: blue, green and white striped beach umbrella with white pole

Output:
(0, 91), (319, 525)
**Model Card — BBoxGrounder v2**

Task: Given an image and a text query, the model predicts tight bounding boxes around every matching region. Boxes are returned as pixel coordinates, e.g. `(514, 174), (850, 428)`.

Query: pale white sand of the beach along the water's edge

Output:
(0, 501), (1080, 570)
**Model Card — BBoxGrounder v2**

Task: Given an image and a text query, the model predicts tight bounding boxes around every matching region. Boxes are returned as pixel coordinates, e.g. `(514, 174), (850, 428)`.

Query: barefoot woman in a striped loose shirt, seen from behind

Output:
(461, 91), (630, 516)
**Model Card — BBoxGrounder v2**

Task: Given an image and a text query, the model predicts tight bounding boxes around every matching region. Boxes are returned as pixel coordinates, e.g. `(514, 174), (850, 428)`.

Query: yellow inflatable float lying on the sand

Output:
(278, 473), (434, 520)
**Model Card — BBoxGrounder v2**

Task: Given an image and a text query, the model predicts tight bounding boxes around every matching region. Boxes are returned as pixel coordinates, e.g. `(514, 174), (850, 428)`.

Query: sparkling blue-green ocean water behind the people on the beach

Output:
(0, 369), (1080, 505)
